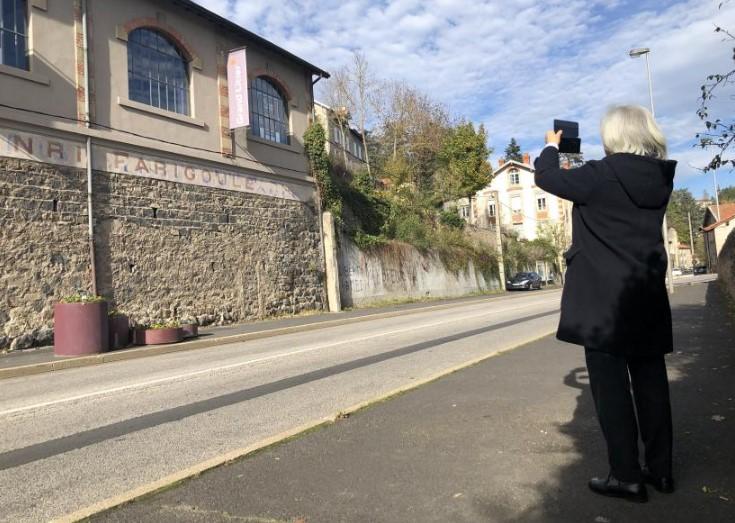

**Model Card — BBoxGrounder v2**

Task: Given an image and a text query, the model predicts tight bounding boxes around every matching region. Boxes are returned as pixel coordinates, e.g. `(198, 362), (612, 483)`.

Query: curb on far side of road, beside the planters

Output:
(0, 290), (556, 380)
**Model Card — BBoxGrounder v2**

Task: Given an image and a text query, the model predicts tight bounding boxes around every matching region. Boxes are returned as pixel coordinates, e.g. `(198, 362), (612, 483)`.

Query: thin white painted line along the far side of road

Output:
(0, 302), (547, 417)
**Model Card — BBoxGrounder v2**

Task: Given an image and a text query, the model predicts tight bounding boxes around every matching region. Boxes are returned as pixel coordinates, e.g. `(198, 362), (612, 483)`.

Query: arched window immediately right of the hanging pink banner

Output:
(250, 76), (288, 144)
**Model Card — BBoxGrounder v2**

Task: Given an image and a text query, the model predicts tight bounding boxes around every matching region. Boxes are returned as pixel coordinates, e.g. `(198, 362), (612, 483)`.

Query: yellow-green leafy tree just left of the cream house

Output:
(439, 122), (492, 211)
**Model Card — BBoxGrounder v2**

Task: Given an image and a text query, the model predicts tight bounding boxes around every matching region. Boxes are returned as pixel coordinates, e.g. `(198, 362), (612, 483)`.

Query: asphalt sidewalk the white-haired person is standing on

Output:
(94, 284), (735, 523)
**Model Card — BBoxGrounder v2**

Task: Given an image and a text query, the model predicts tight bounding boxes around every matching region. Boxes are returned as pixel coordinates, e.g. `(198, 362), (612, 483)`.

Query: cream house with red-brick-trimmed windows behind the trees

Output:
(445, 153), (572, 244)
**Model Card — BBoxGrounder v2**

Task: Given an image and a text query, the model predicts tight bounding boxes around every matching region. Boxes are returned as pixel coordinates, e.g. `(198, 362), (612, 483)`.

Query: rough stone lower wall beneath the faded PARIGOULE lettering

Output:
(0, 158), (325, 349)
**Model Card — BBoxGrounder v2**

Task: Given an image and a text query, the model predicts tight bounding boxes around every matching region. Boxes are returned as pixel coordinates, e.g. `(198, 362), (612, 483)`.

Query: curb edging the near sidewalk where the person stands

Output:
(51, 327), (556, 523)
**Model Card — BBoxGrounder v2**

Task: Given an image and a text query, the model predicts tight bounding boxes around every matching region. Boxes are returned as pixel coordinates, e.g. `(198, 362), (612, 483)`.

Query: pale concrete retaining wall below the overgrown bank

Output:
(339, 236), (500, 307)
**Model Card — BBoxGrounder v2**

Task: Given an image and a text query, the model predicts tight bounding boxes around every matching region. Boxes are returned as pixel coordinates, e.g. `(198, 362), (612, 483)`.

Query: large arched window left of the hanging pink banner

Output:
(128, 28), (189, 114)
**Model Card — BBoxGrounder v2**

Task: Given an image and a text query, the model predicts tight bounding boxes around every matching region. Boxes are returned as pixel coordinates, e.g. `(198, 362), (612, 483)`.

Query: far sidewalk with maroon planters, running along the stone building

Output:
(0, 289), (528, 380)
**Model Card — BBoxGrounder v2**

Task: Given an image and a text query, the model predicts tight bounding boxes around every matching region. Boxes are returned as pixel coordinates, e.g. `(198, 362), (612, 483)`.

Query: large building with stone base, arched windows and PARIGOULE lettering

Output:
(0, 0), (329, 349)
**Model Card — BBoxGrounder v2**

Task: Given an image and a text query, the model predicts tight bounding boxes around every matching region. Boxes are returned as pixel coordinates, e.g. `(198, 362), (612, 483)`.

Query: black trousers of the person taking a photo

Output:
(585, 349), (673, 482)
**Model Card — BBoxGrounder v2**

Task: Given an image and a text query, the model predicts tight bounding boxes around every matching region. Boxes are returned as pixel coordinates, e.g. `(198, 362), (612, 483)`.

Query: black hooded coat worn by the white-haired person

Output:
(535, 147), (676, 355)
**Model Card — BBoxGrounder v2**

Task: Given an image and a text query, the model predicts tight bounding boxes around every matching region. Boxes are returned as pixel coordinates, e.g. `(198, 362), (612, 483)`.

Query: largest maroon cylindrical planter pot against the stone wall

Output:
(54, 301), (110, 356)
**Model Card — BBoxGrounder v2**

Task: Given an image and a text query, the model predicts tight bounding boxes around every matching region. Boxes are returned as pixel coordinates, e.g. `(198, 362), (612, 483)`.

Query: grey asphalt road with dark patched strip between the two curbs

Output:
(0, 291), (560, 522)
